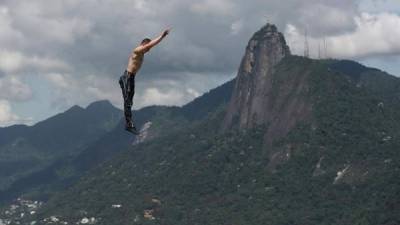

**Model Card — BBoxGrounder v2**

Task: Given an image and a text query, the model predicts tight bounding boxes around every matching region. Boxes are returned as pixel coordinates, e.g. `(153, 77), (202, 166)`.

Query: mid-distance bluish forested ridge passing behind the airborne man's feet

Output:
(0, 81), (234, 202)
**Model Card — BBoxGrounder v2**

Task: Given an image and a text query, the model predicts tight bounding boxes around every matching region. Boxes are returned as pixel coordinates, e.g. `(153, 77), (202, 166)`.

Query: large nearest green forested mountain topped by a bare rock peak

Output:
(0, 24), (400, 225)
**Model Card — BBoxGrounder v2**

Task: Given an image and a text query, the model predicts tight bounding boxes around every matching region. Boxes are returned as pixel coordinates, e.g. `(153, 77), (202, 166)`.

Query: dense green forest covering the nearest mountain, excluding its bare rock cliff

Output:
(26, 57), (400, 225)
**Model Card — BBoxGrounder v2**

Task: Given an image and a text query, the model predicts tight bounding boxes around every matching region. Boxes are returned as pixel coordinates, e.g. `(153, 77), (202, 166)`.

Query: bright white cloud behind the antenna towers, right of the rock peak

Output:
(285, 13), (400, 58)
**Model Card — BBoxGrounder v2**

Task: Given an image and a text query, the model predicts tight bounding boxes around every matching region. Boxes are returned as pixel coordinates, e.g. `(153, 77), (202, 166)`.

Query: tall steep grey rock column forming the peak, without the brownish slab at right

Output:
(224, 24), (290, 128)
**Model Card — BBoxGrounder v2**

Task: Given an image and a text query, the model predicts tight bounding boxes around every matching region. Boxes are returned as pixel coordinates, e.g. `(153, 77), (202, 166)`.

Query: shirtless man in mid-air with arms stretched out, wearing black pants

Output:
(119, 29), (169, 134)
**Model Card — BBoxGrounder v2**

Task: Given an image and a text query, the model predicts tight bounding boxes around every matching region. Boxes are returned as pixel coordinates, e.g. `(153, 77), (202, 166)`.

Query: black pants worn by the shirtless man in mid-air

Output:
(119, 70), (135, 126)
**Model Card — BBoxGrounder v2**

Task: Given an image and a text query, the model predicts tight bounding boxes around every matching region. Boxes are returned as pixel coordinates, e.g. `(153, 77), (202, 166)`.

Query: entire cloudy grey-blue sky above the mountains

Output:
(0, 0), (400, 126)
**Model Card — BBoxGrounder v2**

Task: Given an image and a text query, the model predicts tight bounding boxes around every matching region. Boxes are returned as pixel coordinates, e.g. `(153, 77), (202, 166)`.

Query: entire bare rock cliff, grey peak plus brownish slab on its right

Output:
(223, 24), (311, 141)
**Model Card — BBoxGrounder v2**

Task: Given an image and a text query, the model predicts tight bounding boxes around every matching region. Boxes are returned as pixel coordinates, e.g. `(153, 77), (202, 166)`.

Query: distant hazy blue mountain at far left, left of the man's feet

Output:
(0, 101), (121, 192)
